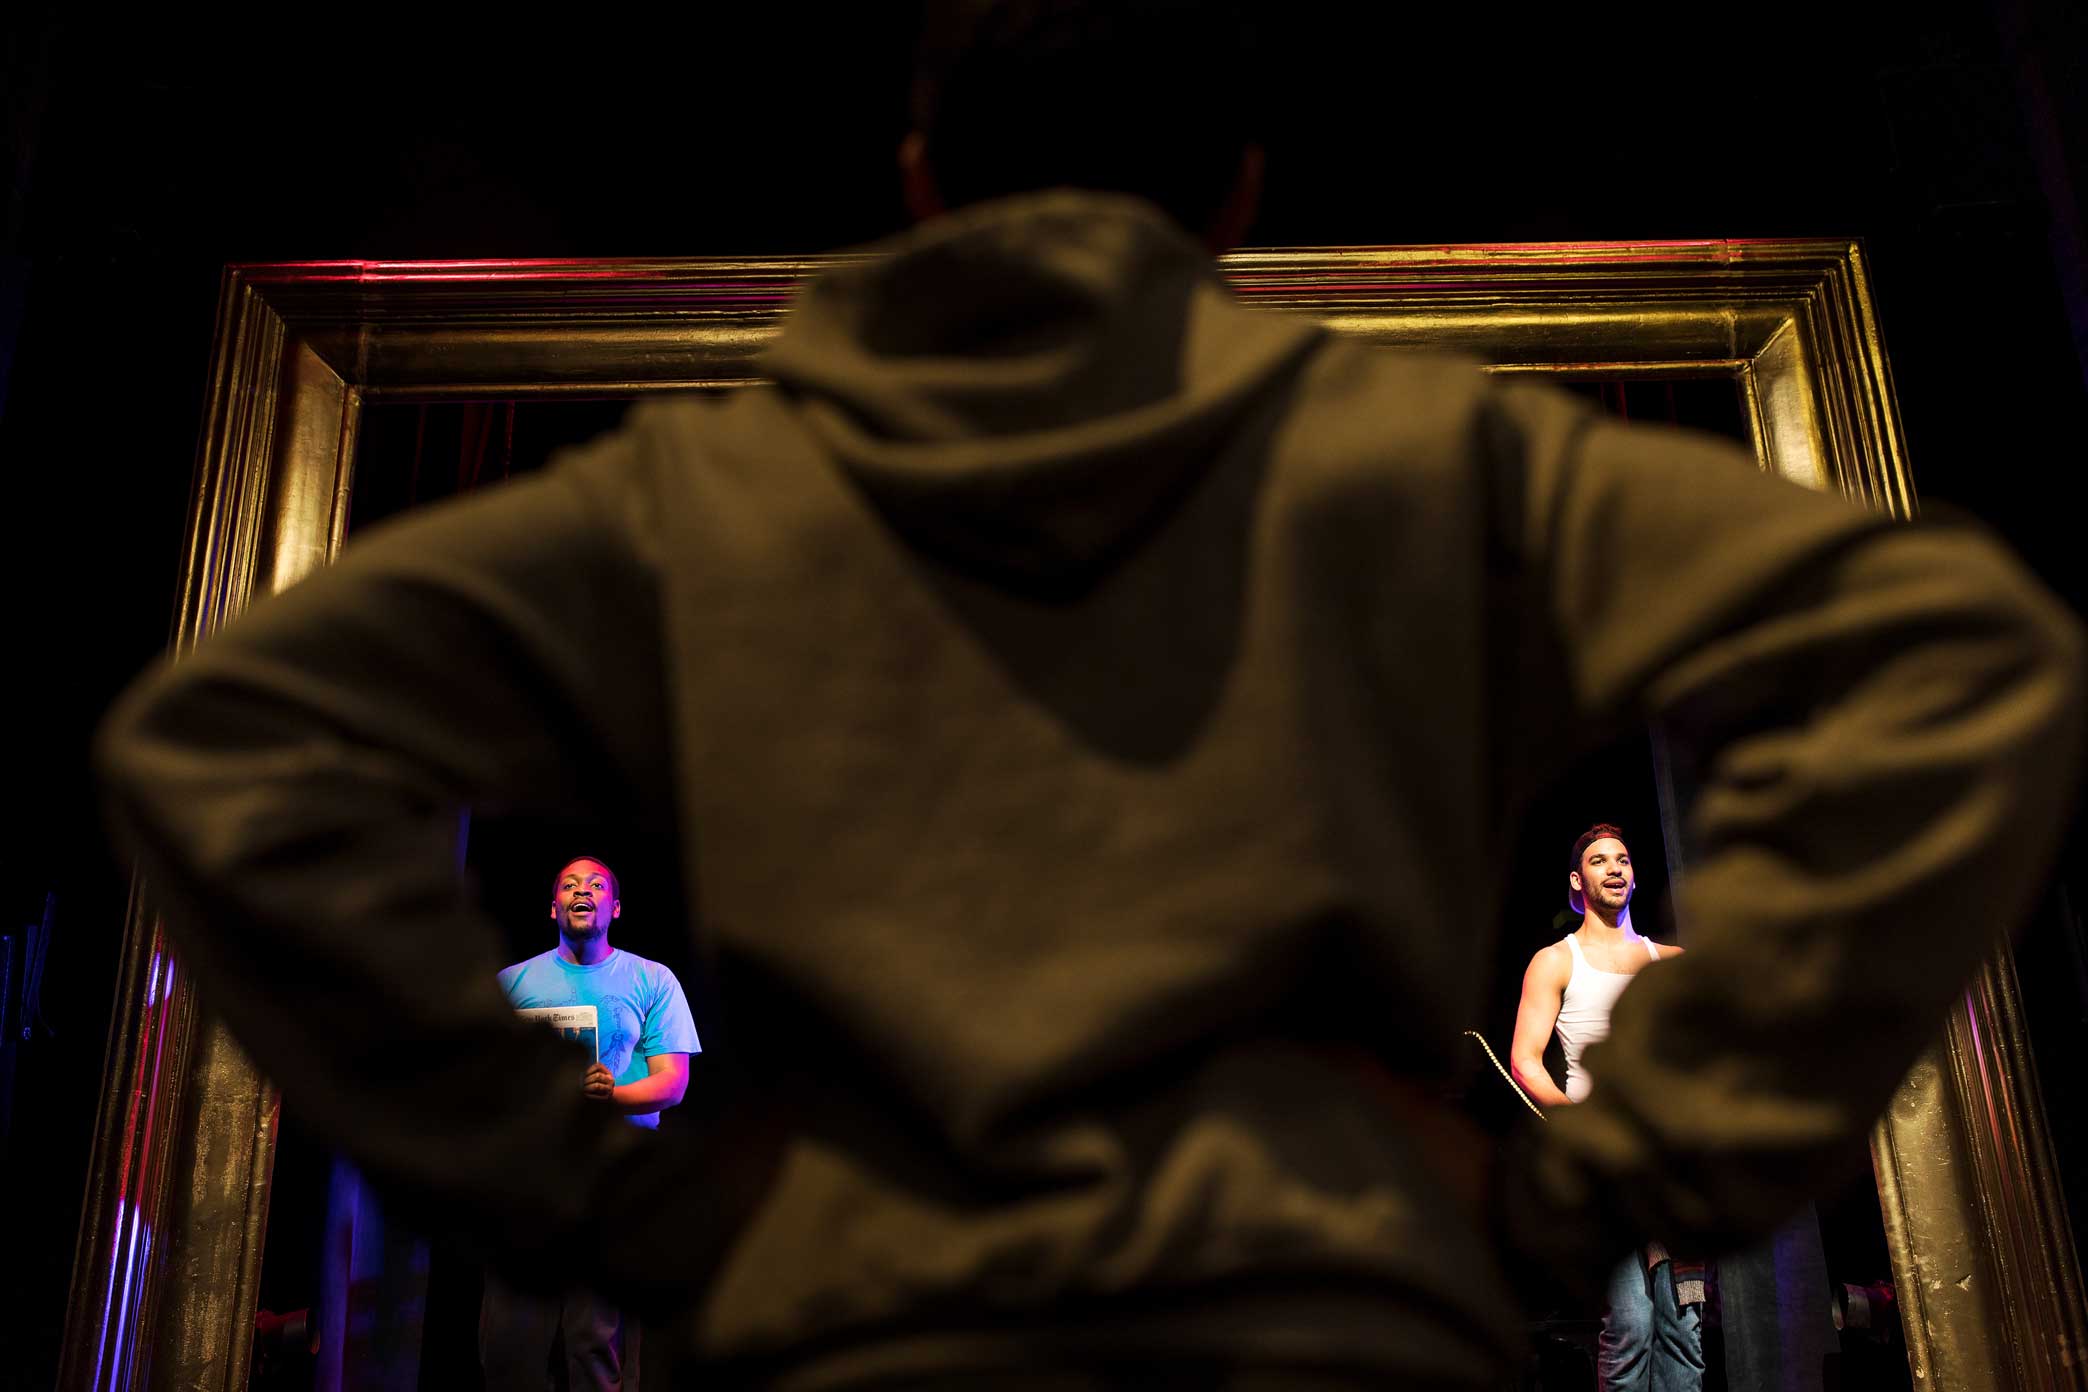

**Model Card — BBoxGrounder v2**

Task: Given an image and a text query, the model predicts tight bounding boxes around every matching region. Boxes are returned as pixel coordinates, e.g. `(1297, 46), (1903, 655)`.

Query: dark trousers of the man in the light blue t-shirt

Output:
(478, 1275), (639, 1392)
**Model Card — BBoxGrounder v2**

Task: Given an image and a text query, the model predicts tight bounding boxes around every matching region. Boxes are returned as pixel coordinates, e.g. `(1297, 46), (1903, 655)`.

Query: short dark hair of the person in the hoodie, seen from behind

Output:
(915, 0), (1261, 234)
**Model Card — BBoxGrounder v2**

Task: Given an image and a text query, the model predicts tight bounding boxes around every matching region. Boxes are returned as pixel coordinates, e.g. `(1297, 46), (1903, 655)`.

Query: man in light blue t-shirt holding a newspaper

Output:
(478, 856), (704, 1392)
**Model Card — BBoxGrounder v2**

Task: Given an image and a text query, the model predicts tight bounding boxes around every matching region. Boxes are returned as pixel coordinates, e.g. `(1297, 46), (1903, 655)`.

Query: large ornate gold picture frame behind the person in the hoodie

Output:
(61, 240), (2088, 1392)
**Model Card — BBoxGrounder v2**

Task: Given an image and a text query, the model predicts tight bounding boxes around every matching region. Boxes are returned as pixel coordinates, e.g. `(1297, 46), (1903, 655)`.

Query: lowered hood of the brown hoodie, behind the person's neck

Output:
(764, 190), (1322, 589)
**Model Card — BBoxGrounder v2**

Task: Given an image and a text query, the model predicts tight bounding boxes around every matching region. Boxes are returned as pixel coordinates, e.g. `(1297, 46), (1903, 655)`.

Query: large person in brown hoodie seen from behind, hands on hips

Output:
(100, 4), (2082, 1388)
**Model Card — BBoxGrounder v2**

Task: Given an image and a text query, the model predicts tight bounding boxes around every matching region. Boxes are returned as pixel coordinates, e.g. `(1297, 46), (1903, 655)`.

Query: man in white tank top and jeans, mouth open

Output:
(1510, 822), (1704, 1392)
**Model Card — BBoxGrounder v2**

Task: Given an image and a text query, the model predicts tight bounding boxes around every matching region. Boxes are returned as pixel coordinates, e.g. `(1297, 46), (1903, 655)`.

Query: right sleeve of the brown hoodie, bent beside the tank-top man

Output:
(1489, 377), (2082, 1283)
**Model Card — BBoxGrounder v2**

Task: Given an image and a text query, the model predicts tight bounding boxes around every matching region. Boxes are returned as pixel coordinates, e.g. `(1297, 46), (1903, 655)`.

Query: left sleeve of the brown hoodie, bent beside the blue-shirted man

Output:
(96, 417), (730, 1310)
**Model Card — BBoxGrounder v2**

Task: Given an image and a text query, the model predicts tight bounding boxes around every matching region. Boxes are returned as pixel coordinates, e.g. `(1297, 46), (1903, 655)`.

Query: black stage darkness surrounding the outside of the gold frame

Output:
(0, 0), (2088, 1388)
